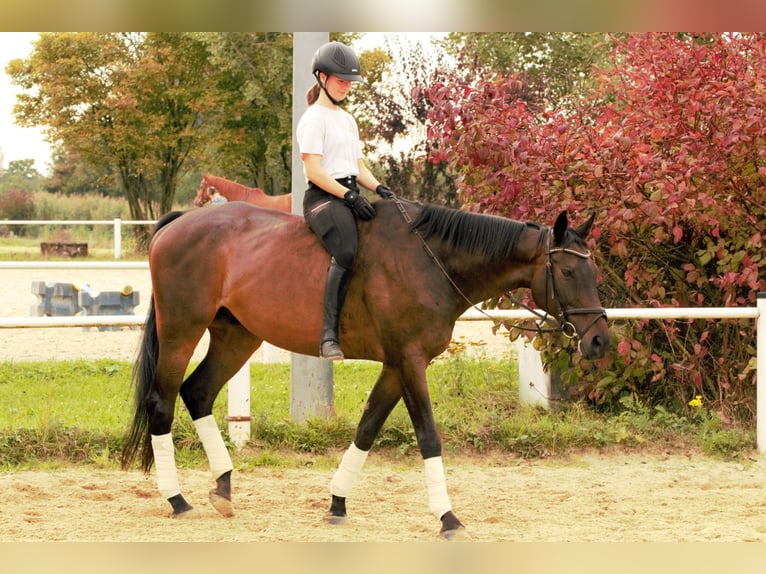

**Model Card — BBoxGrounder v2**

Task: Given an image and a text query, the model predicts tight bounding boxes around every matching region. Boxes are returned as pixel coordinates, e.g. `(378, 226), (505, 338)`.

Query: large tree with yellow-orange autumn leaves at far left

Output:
(6, 33), (230, 245)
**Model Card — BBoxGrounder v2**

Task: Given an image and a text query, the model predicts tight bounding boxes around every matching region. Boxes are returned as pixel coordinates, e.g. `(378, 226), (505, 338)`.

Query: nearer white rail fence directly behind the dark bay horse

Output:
(0, 261), (766, 452)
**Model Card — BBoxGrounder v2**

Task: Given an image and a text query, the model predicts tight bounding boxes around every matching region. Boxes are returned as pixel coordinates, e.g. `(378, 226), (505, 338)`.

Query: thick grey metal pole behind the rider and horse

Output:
(290, 32), (335, 421)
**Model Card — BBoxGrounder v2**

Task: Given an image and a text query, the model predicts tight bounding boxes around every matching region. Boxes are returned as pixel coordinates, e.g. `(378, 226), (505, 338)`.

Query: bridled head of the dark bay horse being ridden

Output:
(531, 211), (611, 359)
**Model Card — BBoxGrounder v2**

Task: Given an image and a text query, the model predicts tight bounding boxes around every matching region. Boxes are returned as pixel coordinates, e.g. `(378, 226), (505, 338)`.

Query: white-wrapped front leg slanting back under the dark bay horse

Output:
(325, 365), (402, 524)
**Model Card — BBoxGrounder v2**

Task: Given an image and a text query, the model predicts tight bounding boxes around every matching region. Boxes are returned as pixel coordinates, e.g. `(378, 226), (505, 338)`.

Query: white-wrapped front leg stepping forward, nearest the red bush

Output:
(402, 362), (465, 540)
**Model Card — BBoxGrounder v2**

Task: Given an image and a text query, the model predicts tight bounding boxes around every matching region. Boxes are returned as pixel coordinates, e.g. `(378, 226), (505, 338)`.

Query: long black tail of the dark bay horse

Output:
(122, 211), (184, 472)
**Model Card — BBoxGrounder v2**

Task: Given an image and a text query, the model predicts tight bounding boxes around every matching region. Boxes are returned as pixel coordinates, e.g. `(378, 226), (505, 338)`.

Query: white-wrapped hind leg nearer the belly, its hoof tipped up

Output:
(181, 318), (261, 517)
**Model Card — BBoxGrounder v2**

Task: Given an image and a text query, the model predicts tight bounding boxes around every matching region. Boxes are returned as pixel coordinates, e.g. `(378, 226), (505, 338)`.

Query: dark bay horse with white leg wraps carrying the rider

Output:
(122, 197), (610, 539)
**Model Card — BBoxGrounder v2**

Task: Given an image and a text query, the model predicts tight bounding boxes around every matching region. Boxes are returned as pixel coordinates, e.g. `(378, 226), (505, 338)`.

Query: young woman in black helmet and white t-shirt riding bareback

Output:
(296, 42), (393, 361)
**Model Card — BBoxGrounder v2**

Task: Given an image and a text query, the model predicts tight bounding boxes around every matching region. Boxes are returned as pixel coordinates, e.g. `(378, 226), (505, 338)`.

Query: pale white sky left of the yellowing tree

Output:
(0, 32), (51, 174)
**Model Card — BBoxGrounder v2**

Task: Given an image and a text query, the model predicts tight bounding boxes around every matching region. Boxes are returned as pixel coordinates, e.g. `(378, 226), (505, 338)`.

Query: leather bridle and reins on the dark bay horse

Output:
(392, 195), (606, 339)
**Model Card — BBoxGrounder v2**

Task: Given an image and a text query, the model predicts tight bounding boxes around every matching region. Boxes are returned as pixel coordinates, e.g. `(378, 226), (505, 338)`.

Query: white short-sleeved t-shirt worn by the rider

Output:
(296, 104), (363, 179)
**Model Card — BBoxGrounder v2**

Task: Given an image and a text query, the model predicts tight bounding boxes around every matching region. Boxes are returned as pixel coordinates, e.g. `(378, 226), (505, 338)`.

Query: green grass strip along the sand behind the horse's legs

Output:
(0, 354), (755, 469)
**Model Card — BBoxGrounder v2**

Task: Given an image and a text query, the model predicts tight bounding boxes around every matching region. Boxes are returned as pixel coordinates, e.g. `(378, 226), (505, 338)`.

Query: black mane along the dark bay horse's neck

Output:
(411, 204), (546, 260)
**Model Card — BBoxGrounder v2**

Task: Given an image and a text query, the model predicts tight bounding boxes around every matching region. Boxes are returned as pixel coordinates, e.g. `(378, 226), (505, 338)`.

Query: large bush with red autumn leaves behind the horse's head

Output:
(428, 33), (766, 424)
